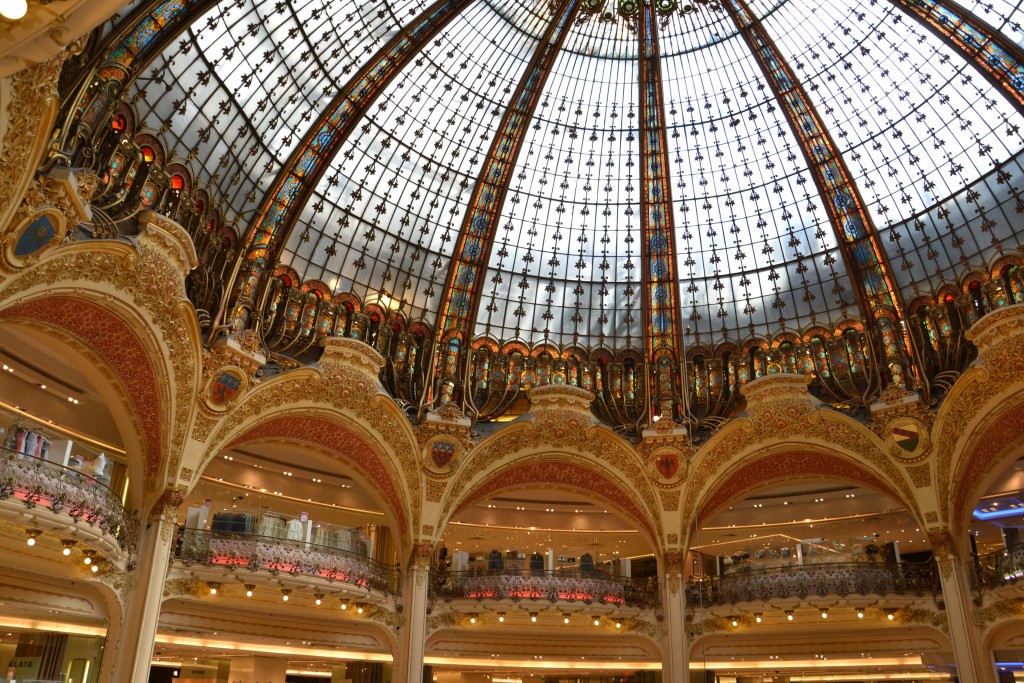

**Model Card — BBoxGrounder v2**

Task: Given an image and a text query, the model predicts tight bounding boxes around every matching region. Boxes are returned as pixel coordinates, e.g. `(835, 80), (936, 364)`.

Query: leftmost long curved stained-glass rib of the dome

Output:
(226, 0), (472, 332)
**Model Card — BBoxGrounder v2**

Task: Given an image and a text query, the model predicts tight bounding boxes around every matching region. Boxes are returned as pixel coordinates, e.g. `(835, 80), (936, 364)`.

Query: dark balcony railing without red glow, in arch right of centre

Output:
(686, 561), (940, 605)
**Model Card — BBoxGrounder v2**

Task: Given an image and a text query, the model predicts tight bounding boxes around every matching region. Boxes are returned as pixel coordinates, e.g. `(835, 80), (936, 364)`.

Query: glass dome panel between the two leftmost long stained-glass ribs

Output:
(282, 1), (550, 323)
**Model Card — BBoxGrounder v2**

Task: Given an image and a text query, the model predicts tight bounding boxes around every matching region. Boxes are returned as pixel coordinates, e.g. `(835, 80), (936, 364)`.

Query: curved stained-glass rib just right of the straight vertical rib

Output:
(724, 0), (910, 389)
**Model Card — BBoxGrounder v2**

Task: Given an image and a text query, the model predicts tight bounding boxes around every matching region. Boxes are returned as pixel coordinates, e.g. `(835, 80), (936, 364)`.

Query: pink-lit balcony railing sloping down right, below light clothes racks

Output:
(174, 527), (398, 595)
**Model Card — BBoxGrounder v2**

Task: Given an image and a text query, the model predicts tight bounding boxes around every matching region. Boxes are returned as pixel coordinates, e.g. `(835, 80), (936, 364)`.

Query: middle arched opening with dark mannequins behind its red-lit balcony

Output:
(426, 483), (662, 680)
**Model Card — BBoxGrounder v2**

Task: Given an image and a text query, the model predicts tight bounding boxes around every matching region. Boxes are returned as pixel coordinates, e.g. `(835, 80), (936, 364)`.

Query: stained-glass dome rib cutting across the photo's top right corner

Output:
(891, 0), (1024, 112)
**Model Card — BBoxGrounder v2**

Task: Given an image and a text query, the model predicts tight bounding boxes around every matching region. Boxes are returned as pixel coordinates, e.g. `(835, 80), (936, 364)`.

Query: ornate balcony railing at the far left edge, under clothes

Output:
(0, 449), (138, 551)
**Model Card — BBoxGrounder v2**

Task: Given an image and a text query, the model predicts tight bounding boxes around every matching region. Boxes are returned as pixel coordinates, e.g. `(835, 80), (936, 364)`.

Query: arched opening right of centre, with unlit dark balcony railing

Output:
(684, 473), (952, 677)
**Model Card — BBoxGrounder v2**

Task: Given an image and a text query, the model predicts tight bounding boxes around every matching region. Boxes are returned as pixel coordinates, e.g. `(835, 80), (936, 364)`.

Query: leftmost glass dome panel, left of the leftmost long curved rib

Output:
(133, 0), (427, 229)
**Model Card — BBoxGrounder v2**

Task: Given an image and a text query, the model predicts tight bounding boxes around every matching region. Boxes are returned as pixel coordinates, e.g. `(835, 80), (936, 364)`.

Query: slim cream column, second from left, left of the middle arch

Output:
(391, 543), (434, 683)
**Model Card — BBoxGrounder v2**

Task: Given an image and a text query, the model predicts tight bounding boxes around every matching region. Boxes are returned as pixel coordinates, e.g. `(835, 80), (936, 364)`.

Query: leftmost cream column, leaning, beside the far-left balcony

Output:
(99, 488), (185, 681)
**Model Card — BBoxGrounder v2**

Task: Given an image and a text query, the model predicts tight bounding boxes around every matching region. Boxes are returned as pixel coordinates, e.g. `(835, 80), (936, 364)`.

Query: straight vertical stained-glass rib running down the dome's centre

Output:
(637, 0), (683, 420)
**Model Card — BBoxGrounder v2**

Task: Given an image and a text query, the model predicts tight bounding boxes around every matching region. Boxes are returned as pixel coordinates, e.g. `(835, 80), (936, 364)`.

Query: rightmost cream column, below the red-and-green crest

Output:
(929, 531), (997, 683)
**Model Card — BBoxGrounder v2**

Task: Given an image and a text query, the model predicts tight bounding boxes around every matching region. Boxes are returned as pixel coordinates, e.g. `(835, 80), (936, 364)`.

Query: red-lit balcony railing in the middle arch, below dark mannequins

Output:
(430, 569), (658, 607)
